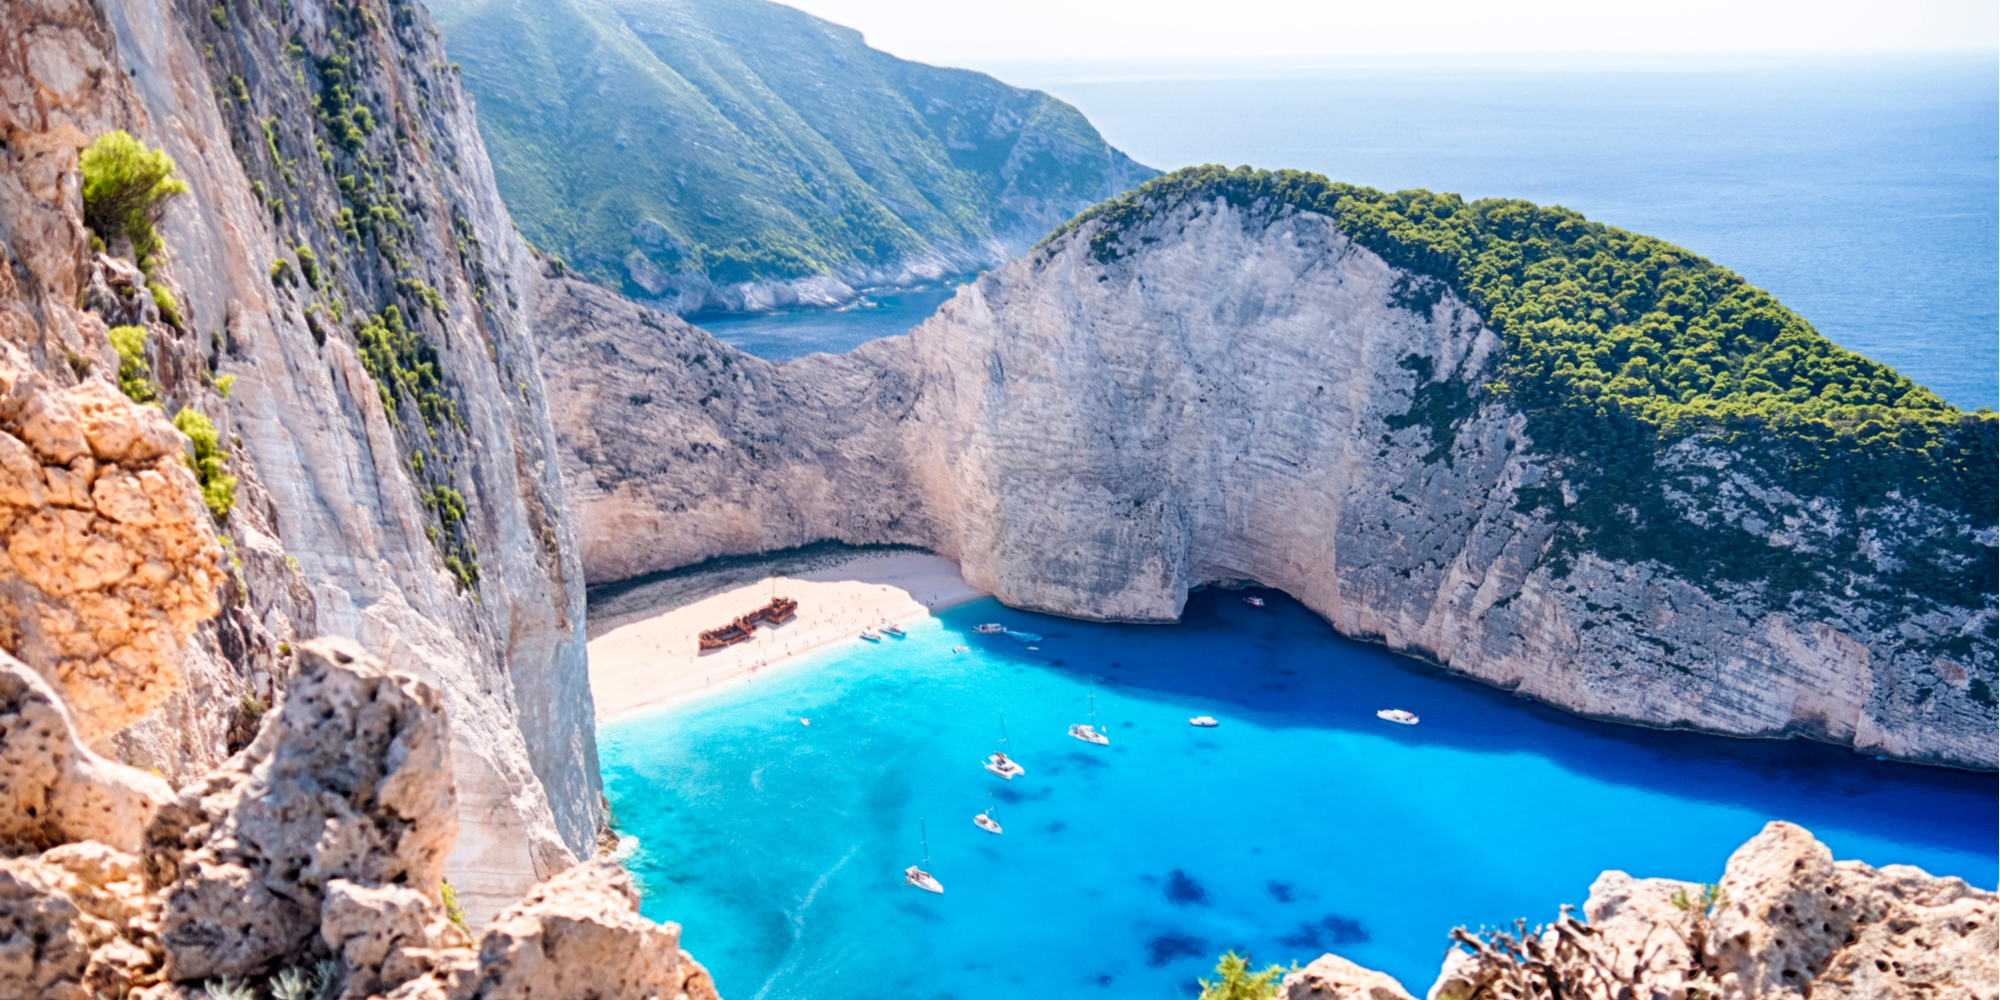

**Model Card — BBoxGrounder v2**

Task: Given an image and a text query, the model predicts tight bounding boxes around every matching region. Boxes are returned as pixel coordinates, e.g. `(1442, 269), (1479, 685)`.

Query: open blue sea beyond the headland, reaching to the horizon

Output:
(698, 54), (2000, 408)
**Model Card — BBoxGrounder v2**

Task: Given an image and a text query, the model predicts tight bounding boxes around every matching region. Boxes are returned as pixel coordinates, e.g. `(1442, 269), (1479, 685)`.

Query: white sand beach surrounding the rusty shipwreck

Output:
(590, 552), (986, 722)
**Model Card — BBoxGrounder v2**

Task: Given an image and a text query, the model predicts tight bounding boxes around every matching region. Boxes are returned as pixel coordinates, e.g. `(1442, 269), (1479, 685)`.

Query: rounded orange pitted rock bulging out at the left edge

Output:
(0, 344), (222, 742)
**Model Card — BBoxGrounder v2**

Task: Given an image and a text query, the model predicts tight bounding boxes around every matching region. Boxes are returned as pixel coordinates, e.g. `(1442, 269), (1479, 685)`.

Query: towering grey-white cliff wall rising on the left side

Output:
(0, 0), (602, 916)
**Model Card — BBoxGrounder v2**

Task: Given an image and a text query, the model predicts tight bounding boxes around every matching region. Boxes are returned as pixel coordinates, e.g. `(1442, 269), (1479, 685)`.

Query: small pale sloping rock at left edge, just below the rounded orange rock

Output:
(0, 652), (174, 852)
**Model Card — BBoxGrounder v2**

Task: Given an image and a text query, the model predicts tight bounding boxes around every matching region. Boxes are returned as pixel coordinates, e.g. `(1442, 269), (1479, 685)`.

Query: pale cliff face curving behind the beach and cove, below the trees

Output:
(538, 176), (1994, 768)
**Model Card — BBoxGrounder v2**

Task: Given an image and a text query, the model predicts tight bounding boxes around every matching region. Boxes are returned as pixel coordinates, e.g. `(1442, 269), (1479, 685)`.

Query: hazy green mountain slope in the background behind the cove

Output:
(432, 0), (1156, 298)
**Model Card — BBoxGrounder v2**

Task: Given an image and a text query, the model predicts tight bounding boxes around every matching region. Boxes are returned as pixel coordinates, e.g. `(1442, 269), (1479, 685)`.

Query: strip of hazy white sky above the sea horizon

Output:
(786, 0), (2000, 64)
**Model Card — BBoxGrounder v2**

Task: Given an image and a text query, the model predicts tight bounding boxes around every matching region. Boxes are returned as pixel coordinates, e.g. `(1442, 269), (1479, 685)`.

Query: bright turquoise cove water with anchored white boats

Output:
(598, 590), (2000, 1000)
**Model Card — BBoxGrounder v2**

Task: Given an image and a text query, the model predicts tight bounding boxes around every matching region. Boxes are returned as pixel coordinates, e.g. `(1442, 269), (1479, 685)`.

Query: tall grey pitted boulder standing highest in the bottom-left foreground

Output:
(146, 638), (458, 982)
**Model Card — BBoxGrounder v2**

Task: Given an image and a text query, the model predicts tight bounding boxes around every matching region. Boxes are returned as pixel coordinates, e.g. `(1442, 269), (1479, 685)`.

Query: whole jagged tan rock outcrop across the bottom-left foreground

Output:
(0, 640), (716, 1000)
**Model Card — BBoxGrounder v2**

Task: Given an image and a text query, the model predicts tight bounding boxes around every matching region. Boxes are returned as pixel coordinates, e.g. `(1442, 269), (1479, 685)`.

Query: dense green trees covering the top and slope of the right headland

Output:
(1044, 166), (2000, 606)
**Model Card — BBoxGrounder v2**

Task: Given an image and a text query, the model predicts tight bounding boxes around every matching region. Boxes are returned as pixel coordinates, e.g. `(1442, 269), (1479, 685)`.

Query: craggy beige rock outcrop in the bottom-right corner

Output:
(1432, 822), (2000, 1000)
